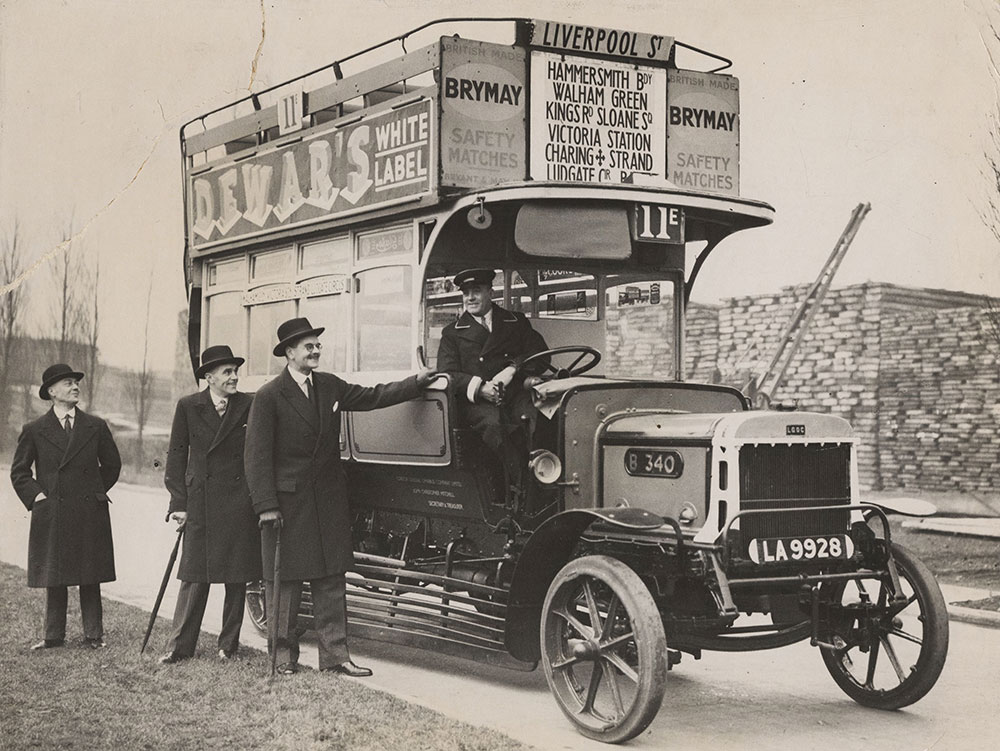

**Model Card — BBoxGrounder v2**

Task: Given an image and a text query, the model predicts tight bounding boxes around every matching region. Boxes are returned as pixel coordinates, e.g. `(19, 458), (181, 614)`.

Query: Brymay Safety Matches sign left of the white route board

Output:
(440, 38), (527, 188)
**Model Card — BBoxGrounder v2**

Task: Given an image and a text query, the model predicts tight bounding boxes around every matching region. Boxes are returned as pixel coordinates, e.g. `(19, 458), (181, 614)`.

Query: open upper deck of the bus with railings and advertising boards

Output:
(181, 18), (739, 252)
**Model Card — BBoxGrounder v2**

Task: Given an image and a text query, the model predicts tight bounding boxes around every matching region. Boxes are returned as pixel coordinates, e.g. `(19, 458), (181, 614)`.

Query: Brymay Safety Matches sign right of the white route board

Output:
(667, 70), (740, 196)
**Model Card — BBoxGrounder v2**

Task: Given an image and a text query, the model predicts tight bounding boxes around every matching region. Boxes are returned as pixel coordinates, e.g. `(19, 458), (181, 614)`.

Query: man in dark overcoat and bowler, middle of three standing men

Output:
(160, 344), (261, 664)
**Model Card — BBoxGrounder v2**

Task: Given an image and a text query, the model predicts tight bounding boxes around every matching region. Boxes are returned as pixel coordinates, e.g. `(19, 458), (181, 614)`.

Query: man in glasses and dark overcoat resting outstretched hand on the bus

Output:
(244, 318), (433, 677)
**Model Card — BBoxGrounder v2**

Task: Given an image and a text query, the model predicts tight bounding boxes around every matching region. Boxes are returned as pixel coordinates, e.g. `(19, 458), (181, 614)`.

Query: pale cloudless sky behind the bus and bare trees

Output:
(0, 0), (1000, 369)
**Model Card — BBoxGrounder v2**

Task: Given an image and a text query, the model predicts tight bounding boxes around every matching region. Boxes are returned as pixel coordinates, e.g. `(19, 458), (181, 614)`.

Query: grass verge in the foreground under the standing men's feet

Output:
(0, 564), (525, 751)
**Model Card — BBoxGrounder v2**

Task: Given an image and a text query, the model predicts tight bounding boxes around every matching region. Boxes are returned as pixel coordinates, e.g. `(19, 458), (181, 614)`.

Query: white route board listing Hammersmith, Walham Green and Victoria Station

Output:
(531, 52), (667, 183)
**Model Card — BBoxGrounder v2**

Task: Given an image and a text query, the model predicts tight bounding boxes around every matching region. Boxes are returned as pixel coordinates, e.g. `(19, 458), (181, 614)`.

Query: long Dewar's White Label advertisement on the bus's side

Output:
(188, 100), (434, 249)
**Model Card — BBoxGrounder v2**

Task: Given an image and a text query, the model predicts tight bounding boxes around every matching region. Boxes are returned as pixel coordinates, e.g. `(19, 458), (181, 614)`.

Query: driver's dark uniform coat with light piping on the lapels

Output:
(437, 305), (548, 451)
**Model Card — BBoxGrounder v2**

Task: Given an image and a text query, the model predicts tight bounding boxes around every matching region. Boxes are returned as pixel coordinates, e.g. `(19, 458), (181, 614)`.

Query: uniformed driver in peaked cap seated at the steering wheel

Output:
(437, 269), (548, 494)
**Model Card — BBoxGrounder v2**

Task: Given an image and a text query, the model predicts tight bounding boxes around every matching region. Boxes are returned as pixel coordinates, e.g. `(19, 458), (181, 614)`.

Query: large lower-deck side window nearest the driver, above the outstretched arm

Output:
(355, 266), (413, 371)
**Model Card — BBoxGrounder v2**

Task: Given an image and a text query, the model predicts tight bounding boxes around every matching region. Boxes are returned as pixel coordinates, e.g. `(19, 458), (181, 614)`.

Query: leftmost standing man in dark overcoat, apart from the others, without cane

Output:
(10, 363), (122, 649)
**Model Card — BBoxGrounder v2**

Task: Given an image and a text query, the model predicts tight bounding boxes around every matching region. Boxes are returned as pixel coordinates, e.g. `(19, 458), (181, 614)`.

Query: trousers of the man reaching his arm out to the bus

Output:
(264, 574), (351, 670)
